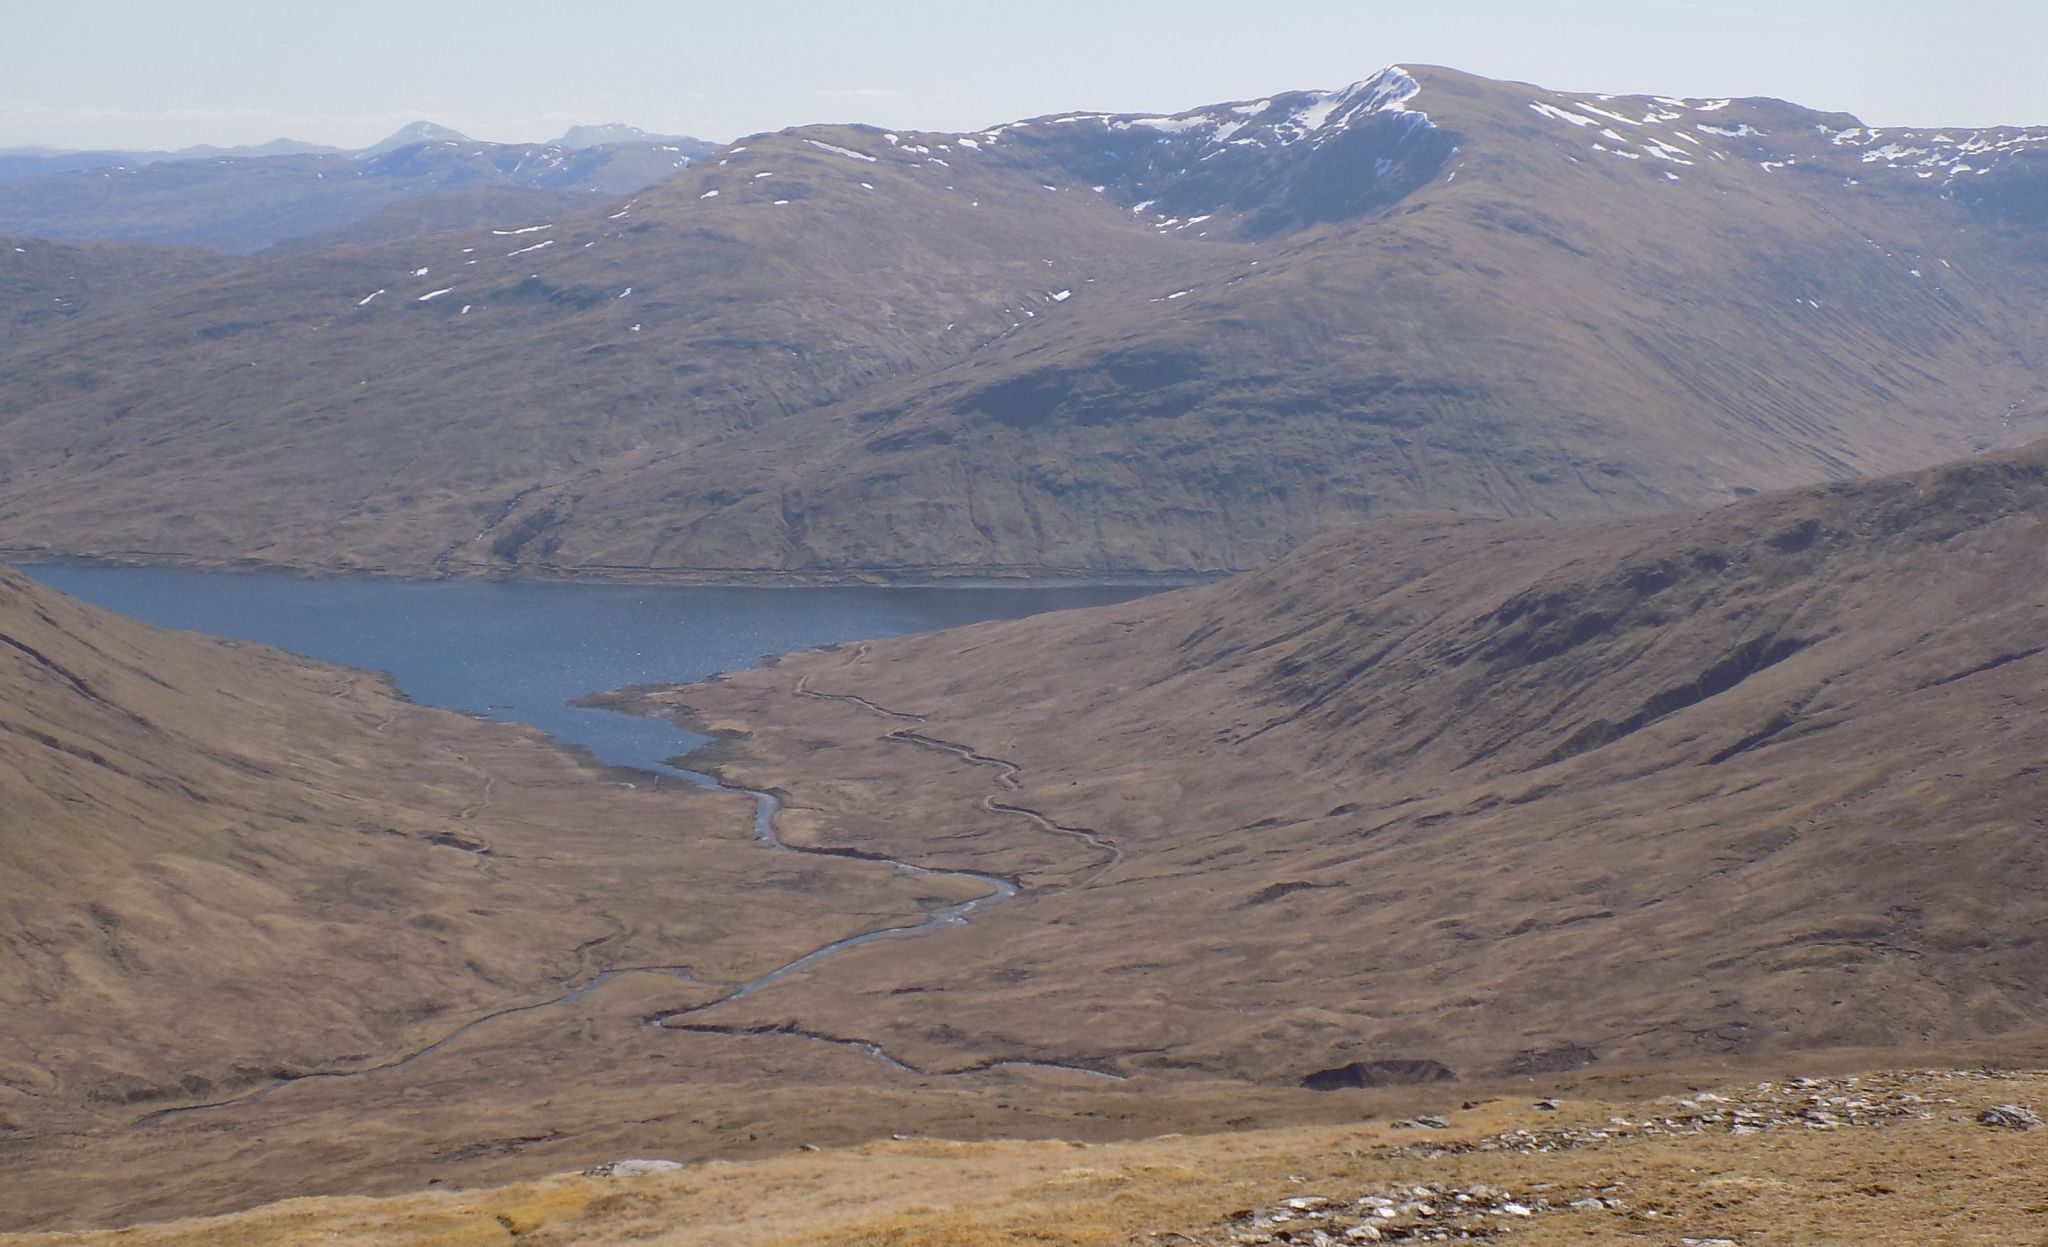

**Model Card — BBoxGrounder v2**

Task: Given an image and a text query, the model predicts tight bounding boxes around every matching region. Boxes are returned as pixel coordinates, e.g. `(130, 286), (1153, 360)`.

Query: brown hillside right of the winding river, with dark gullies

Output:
(627, 442), (2048, 1087)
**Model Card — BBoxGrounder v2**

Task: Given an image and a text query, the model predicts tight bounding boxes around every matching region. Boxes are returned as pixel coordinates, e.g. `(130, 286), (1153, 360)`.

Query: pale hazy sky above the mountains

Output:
(0, 0), (2048, 147)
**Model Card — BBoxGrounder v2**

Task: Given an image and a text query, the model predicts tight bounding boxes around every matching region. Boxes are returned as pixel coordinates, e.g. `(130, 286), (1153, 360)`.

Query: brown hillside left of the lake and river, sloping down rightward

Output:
(0, 569), (928, 1163)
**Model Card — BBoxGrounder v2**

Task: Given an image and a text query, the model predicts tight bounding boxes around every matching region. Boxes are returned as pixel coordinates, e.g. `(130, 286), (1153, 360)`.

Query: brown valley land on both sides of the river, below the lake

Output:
(0, 446), (2048, 1233)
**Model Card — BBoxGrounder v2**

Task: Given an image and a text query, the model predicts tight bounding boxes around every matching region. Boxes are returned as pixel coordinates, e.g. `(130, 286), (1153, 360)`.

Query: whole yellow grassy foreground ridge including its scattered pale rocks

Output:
(12, 1067), (2048, 1247)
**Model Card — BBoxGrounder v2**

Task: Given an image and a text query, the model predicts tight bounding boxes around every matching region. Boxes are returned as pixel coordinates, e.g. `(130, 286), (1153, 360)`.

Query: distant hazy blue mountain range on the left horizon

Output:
(0, 121), (711, 254)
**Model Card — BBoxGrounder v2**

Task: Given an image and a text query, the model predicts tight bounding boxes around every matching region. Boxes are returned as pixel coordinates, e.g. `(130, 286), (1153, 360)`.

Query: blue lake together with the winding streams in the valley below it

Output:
(27, 565), (1149, 1126)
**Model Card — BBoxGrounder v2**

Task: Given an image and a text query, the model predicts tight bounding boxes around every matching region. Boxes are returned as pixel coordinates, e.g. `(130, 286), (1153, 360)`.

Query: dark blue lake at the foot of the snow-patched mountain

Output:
(23, 565), (1149, 770)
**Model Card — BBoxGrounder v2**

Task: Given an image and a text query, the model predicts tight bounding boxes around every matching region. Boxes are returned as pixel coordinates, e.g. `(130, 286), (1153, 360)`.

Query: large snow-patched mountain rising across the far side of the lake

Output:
(0, 68), (2048, 577)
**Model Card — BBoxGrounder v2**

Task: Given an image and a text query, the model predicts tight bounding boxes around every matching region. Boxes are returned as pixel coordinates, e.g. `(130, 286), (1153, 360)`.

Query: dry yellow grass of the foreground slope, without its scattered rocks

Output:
(12, 1071), (2048, 1247)
